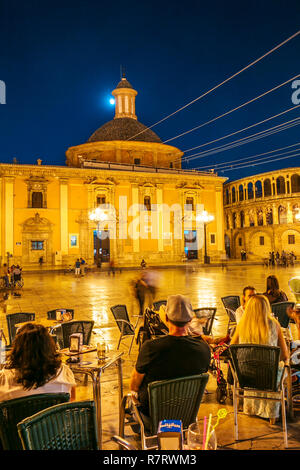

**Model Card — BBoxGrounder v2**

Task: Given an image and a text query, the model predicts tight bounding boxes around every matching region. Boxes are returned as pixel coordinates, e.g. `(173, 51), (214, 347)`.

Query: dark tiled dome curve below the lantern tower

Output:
(88, 118), (162, 144)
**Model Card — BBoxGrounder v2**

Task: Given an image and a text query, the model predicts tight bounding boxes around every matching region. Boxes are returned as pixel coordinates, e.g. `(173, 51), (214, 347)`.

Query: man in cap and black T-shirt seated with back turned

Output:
(130, 295), (210, 416)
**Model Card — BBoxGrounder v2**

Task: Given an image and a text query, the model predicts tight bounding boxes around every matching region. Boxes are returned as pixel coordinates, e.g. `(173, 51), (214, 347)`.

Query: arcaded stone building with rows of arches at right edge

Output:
(224, 167), (300, 259)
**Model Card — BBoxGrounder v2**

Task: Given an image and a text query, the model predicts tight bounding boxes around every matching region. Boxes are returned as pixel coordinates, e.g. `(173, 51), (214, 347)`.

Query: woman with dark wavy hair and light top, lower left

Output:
(0, 323), (76, 401)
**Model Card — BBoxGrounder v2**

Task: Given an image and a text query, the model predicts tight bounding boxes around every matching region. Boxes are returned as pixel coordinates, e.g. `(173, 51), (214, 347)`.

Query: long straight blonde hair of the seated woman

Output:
(238, 295), (273, 344)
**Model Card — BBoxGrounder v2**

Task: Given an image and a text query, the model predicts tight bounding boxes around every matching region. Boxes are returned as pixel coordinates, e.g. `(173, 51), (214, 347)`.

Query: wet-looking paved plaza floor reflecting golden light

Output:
(0, 264), (300, 450)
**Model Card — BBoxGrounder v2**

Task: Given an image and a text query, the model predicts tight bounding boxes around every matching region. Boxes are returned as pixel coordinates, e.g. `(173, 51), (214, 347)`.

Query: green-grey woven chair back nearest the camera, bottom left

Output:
(18, 401), (98, 450)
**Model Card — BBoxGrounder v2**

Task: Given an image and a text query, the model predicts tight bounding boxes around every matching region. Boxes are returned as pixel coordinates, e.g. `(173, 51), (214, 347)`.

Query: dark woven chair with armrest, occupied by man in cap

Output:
(119, 373), (209, 450)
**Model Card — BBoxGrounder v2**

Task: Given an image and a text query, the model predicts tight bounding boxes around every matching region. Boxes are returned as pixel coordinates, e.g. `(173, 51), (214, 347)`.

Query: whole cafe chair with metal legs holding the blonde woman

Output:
(229, 344), (289, 447)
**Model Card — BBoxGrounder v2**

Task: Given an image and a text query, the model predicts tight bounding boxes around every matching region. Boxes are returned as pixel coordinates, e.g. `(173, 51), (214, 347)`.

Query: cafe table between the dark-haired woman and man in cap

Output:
(60, 349), (124, 449)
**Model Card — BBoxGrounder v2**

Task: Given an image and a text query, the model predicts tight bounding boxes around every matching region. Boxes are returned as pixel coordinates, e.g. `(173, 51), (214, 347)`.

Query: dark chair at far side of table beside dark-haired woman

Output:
(52, 320), (94, 348)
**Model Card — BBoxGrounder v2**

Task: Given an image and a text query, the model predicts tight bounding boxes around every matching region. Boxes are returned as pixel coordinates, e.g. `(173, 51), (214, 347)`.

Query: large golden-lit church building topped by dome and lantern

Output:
(0, 77), (226, 267)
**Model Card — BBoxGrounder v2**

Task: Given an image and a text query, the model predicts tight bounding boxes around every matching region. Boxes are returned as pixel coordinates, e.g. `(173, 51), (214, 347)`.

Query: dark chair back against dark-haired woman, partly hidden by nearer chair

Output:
(0, 393), (70, 450)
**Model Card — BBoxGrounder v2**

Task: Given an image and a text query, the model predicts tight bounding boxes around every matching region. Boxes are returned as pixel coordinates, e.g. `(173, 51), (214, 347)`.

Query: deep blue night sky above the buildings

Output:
(0, 0), (300, 180)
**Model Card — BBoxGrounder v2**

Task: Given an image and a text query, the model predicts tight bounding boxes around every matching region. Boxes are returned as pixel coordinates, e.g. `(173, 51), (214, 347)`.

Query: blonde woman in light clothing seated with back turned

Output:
(231, 295), (289, 424)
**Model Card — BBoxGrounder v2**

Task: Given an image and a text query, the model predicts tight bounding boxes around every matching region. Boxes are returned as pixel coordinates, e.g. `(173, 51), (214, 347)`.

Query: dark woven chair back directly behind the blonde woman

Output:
(229, 344), (280, 392)
